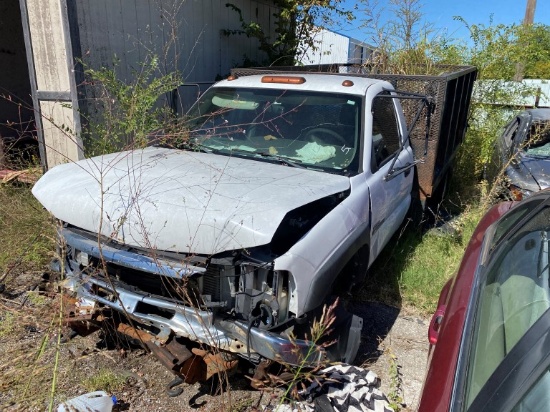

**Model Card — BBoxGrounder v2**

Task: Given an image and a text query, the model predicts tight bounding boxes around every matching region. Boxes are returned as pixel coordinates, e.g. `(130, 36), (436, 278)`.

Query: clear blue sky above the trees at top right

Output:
(336, 0), (550, 43)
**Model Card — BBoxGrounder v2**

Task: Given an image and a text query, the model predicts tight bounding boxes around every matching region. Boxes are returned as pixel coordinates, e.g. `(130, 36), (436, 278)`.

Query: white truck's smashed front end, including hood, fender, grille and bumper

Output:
(33, 148), (362, 385)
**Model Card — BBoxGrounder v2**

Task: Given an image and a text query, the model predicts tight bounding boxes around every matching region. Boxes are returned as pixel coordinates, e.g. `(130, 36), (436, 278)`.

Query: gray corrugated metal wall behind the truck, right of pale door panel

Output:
(75, 0), (276, 81)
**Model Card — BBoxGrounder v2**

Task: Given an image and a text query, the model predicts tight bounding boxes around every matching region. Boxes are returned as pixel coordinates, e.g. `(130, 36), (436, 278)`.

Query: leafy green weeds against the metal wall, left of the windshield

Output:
(83, 57), (181, 156)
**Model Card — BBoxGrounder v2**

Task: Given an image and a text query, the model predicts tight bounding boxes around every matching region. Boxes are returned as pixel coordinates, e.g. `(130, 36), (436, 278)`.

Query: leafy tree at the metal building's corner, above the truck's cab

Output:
(224, 0), (353, 66)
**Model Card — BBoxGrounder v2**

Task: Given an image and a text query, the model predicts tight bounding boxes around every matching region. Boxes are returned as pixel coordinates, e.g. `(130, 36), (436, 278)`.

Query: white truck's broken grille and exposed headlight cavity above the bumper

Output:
(64, 230), (289, 329)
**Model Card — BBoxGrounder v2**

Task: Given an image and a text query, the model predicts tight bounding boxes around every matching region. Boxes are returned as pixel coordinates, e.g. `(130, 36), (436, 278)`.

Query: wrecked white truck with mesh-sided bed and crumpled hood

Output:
(33, 67), (476, 381)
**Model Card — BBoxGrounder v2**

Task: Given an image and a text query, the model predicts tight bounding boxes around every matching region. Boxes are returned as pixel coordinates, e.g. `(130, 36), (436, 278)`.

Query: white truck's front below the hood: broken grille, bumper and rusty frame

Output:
(60, 227), (326, 380)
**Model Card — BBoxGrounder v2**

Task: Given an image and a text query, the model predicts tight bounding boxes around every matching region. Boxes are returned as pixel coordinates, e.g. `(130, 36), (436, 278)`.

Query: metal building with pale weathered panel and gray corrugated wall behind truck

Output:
(4, 0), (276, 167)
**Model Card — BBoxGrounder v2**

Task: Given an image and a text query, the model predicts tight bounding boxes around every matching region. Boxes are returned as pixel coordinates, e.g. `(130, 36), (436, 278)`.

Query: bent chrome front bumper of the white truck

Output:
(66, 274), (326, 365)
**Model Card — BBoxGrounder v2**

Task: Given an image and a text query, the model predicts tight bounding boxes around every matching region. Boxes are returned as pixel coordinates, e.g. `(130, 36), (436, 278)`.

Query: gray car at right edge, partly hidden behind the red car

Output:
(495, 108), (550, 200)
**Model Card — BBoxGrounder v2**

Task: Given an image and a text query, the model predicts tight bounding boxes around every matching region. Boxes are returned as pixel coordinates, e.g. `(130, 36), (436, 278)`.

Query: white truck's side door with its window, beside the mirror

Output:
(365, 91), (414, 261)
